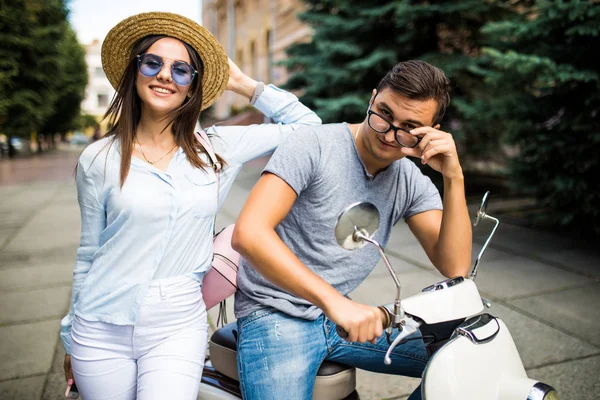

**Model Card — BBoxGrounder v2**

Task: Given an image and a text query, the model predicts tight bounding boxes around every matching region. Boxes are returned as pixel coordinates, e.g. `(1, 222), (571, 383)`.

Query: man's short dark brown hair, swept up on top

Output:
(377, 60), (450, 124)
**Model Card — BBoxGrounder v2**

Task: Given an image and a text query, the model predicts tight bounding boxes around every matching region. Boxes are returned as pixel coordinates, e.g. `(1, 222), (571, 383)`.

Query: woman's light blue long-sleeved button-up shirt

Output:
(61, 85), (321, 354)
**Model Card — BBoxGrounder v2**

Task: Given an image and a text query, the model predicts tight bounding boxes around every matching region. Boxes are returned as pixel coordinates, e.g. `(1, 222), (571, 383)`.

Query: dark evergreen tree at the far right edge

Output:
(472, 0), (600, 233)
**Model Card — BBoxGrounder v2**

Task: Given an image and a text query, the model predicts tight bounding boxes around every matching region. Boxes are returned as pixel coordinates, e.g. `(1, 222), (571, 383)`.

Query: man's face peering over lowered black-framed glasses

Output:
(359, 88), (437, 168)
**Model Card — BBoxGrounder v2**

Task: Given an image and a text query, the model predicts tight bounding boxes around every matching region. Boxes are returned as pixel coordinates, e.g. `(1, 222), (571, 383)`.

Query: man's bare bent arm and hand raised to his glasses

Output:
(406, 125), (472, 278)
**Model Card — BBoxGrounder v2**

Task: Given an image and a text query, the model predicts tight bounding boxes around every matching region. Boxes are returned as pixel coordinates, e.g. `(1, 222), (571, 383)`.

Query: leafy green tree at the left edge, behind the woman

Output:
(0, 0), (87, 153)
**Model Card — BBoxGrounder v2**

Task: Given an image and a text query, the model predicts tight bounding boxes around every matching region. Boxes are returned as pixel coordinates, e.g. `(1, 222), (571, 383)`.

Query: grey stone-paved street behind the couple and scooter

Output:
(0, 150), (600, 400)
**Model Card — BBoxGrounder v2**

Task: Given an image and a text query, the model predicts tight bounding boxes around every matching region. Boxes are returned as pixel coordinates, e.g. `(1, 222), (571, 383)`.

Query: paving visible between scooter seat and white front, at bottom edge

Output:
(356, 368), (421, 400)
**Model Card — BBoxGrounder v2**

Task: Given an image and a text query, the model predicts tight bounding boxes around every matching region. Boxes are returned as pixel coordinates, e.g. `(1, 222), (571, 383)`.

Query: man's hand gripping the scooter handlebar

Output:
(324, 296), (387, 343)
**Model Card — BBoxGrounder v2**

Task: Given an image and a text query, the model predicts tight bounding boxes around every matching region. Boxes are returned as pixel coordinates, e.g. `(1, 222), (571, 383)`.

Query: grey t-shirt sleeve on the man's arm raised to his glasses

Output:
(401, 160), (442, 220)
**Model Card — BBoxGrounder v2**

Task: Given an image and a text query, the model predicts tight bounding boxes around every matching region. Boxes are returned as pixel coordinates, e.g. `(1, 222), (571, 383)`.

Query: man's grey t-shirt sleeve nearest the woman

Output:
(263, 127), (321, 196)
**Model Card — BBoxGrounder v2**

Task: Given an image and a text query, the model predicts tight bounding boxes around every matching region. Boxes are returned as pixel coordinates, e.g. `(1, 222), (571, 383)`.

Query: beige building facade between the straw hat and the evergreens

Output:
(202, 0), (312, 119)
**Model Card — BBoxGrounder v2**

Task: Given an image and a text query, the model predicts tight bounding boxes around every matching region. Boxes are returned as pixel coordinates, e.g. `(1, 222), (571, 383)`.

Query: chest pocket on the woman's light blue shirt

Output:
(185, 170), (218, 218)
